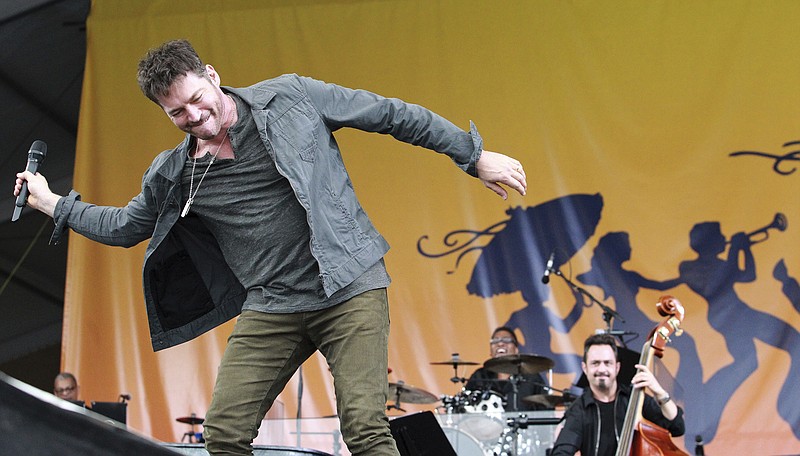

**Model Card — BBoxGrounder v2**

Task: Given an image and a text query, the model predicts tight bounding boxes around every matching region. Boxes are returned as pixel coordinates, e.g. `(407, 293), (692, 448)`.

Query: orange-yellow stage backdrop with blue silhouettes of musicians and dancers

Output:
(63, 0), (800, 454)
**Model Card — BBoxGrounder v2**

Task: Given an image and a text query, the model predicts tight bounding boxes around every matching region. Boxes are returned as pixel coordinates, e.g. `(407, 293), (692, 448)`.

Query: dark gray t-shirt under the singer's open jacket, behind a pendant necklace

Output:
(182, 94), (391, 313)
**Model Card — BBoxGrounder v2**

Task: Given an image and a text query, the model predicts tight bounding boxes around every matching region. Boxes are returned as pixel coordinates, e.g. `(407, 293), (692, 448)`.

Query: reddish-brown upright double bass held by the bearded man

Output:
(616, 296), (688, 456)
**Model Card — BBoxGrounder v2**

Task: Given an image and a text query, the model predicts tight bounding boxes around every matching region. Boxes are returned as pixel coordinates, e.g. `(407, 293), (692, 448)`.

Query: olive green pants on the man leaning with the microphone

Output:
(204, 289), (399, 456)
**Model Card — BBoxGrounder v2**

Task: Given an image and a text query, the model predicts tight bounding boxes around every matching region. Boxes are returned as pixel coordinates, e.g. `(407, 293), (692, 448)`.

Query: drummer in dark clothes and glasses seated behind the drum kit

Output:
(466, 326), (547, 412)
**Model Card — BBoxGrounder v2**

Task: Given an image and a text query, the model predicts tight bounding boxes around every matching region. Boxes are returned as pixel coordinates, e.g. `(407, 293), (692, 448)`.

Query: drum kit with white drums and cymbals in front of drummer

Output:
(387, 353), (574, 456)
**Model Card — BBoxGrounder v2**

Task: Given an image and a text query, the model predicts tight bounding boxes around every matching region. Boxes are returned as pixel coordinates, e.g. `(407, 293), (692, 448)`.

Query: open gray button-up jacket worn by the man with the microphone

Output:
(51, 75), (482, 351)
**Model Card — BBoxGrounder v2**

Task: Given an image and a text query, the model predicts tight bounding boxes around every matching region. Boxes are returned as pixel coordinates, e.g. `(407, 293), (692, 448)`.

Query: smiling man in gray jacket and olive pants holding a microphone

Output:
(14, 40), (527, 456)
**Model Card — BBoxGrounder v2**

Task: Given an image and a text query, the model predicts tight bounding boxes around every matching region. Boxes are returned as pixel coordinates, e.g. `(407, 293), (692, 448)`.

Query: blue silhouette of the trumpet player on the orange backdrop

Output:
(679, 222), (800, 442)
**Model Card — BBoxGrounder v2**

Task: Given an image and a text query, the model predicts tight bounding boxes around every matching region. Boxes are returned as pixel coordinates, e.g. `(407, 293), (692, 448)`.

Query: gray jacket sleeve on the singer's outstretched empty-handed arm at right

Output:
(297, 76), (483, 177)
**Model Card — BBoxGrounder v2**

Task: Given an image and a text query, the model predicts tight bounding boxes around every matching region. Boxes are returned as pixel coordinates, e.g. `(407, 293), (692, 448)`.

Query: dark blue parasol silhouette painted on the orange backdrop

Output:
(467, 193), (603, 297)
